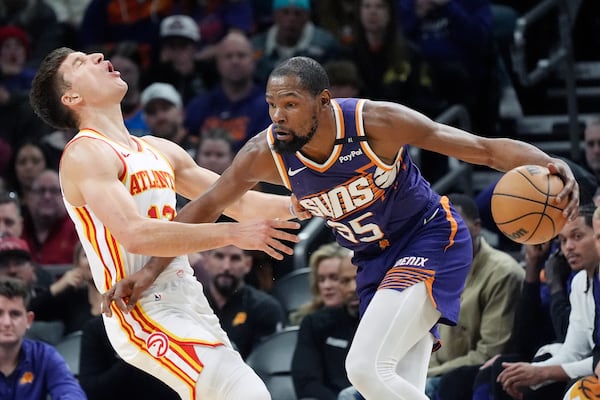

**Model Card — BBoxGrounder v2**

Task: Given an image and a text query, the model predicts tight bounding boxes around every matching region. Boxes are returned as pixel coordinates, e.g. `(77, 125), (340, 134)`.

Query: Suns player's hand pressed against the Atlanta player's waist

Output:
(100, 268), (156, 317)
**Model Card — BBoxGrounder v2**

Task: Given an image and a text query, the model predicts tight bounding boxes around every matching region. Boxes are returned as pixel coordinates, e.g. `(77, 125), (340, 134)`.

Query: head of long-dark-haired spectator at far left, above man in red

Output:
(8, 140), (48, 206)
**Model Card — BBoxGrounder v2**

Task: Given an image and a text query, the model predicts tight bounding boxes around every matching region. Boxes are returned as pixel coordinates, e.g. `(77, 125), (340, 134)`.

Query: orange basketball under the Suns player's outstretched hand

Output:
(491, 165), (568, 244)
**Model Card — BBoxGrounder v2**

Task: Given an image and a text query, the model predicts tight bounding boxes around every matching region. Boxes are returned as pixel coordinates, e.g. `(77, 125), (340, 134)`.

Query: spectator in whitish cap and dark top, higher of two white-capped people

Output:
(143, 15), (216, 105)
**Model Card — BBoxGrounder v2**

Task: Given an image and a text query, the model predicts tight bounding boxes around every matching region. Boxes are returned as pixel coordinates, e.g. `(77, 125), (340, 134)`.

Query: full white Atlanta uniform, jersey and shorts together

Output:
(64, 130), (237, 400)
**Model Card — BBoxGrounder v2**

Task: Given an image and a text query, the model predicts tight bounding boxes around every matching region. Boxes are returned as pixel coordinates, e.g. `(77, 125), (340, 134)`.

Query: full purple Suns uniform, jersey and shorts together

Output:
(267, 99), (472, 324)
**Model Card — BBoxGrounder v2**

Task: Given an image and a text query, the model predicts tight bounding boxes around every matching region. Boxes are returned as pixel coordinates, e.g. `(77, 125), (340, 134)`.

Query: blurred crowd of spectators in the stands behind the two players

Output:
(0, 0), (600, 400)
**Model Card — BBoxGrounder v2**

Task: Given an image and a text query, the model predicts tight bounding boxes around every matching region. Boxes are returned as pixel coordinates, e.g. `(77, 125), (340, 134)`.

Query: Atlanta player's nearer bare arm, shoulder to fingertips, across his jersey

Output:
(60, 139), (299, 257)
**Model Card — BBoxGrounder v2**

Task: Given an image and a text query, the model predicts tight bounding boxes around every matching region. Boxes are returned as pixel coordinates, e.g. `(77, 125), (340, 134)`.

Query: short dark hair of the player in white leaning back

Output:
(29, 47), (79, 130)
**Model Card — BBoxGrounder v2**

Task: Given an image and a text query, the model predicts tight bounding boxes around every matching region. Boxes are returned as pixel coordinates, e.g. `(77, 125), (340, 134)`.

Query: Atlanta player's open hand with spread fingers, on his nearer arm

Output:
(231, 219), (300, 260)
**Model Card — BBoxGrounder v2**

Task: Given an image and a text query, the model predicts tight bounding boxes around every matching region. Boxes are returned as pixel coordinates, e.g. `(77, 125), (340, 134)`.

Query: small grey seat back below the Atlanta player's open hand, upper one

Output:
(271, 267), (312, 315)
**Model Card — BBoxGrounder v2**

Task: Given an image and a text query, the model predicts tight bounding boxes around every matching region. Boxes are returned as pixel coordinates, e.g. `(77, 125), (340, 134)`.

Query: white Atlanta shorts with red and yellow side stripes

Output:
(104, 270), (233, 400)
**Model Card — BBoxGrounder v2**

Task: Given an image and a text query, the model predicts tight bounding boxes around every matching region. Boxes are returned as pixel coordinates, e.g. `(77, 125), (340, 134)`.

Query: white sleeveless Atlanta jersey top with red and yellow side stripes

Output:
(64, 130), (193, 293)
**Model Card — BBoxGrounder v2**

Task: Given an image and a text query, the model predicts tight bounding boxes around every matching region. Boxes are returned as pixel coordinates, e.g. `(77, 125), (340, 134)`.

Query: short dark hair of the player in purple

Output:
(270, 57), (329, 96)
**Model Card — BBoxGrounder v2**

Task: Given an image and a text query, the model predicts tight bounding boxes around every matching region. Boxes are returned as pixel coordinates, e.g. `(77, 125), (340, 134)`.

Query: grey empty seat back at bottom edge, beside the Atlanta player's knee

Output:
(246, 327), (298, 400)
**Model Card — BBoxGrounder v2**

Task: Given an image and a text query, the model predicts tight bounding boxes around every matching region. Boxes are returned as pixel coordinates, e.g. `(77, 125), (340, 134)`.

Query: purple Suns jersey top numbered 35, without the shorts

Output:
(269, 99), (440, 256)
